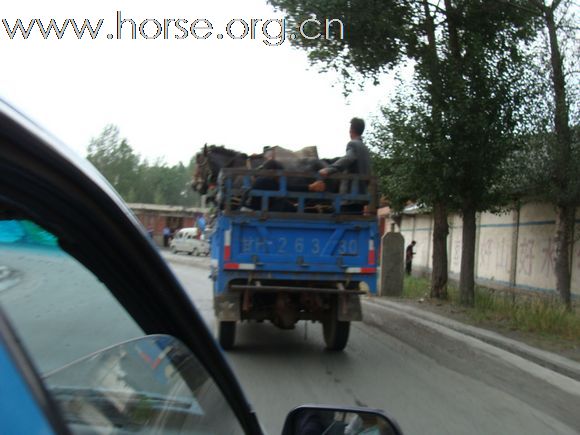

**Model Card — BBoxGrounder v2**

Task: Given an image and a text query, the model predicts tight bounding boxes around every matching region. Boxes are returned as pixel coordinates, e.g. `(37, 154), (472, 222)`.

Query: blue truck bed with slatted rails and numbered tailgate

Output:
(211, 169), (379, 294)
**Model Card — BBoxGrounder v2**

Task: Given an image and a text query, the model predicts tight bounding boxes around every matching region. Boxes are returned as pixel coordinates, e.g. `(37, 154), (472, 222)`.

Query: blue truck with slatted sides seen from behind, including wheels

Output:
(210, 169), (379, 350)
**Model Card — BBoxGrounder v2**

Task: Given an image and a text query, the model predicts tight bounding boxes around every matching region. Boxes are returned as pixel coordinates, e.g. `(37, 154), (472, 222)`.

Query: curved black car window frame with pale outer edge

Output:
(0, 100), (263, 434)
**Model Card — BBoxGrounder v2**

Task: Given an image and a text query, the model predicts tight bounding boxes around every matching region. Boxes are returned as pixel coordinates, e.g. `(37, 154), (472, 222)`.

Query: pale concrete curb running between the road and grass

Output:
(363, 297), (580, 381)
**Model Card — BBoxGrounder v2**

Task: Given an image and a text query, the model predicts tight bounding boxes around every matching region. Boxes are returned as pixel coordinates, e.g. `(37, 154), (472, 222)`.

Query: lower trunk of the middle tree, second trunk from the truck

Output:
(459, 206), (476, 307)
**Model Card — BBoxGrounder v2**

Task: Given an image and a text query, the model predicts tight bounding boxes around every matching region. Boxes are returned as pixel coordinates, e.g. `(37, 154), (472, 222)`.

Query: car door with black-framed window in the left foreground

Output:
(0, 103), (262, 434)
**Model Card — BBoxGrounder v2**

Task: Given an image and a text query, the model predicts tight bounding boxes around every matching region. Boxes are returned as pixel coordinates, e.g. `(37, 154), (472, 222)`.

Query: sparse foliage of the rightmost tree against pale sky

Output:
(522, 0), (580, 207)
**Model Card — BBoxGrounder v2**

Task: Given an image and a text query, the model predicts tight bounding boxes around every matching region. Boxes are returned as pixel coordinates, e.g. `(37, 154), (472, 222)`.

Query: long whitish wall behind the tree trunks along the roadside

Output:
(399, 203), (580, 296)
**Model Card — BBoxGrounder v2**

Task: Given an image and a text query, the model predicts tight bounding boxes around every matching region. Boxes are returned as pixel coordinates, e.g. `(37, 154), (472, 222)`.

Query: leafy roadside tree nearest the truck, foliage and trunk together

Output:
(374, 0), (452, 299)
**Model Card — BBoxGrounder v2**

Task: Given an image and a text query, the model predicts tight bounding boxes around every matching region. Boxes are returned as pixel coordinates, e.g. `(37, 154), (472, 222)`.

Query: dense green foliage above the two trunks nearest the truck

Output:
(364, 1), (537, 217)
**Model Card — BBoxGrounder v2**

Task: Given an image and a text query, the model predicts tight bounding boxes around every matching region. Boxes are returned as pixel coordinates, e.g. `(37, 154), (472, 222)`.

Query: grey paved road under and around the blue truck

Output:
(173, 263), (580, 434)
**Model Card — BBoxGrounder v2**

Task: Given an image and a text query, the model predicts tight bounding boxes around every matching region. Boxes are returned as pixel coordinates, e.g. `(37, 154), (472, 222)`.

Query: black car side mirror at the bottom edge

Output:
(282, 405), (403, 435)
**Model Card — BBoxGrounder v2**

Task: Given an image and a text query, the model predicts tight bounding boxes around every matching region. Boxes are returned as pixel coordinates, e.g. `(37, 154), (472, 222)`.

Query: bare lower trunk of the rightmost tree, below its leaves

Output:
(555, 206), (576, 310)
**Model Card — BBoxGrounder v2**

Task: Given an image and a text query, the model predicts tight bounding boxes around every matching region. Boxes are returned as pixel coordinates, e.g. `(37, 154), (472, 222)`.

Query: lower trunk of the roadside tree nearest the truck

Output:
(431, 202), (449, 299)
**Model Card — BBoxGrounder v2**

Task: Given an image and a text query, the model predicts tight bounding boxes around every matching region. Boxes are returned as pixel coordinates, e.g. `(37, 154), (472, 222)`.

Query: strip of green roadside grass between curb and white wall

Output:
(403, 276), (580, 342)
